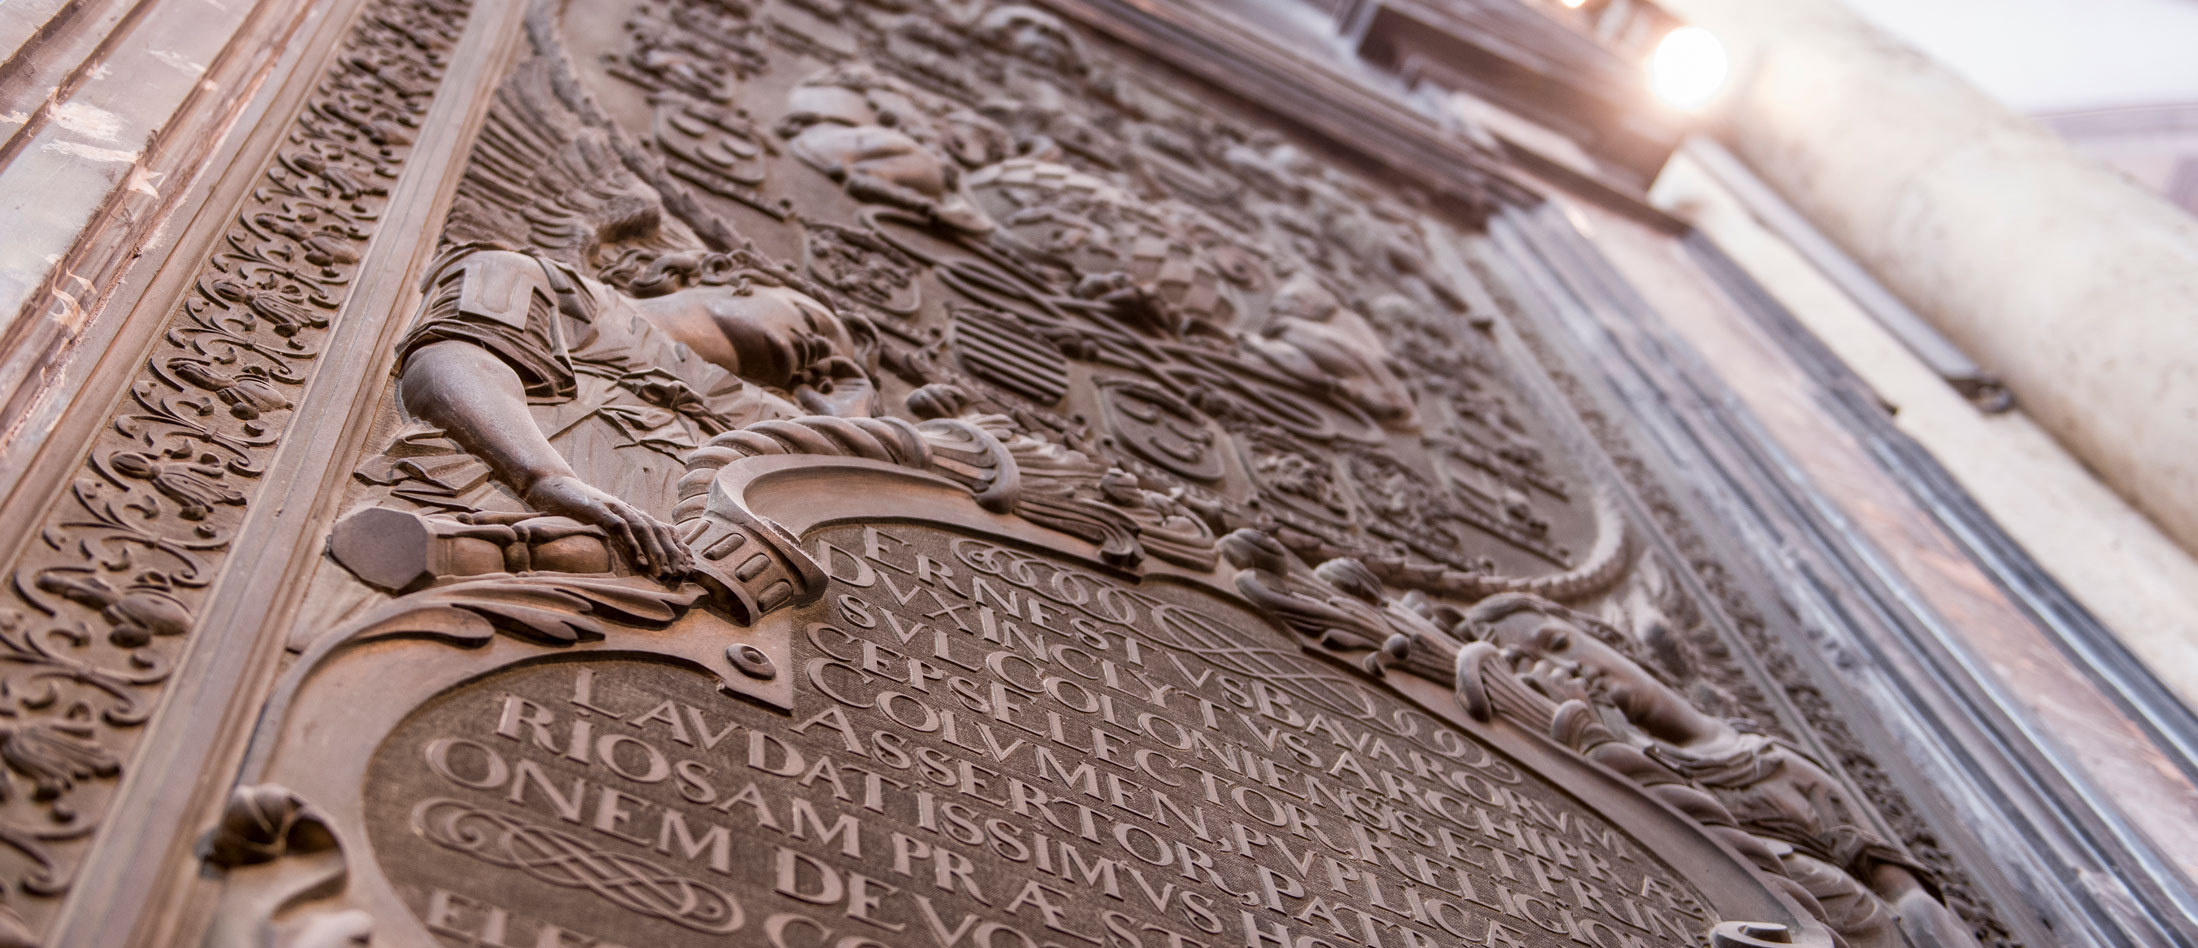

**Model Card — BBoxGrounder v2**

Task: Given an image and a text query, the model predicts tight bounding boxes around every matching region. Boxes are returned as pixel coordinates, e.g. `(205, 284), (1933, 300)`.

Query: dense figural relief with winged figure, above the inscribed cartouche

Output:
(309, 2), (1624, 637)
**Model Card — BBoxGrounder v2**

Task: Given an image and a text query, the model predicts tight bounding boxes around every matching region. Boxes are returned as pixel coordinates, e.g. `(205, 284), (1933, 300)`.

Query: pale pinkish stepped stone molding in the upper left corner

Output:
(0, 0), (320, 490)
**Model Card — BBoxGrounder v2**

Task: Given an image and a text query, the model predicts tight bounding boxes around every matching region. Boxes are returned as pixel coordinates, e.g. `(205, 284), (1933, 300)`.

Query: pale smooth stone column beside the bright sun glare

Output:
(1664, 0), (2198, 552)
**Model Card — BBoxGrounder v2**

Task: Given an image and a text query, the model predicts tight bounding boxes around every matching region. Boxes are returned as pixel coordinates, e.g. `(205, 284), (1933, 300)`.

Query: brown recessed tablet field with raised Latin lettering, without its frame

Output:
(367, 526), (1714, 948)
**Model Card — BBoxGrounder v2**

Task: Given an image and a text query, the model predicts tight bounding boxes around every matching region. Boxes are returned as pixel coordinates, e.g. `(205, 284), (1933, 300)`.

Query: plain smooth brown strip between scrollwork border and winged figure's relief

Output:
(46, 0), (540, 944)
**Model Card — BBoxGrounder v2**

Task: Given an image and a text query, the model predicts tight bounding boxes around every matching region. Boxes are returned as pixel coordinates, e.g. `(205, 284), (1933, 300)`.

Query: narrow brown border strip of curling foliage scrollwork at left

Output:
(0, 0), (468, 939)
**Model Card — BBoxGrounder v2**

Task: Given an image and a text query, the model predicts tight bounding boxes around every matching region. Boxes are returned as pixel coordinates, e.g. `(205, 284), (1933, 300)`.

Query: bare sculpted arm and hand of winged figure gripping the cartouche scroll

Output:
(398, 341), (690, 576)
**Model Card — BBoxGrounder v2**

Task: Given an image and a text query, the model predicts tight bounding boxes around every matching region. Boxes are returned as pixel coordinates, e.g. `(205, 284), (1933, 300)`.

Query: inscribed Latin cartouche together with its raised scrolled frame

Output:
(213, 475), (1833, 948)
